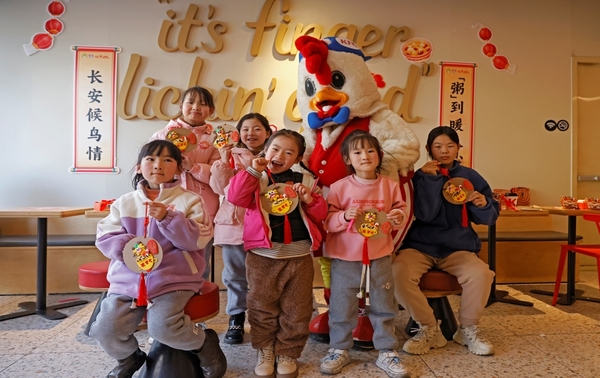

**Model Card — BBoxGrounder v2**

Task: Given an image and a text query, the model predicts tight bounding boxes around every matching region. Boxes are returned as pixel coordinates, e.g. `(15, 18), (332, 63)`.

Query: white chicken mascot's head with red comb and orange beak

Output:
(296, 36), (385, 130)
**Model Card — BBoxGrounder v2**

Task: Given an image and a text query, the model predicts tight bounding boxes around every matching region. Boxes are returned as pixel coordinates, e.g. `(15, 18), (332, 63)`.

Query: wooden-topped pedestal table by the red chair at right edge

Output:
(531, 206), (600, 306)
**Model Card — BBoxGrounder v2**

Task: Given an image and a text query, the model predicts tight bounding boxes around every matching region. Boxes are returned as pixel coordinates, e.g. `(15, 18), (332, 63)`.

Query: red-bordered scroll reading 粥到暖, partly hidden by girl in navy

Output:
(438, 62), (477, 167)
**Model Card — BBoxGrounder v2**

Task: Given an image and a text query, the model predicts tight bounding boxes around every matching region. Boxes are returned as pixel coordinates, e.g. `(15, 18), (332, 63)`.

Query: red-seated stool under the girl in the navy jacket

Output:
(404, 269), (462, 340)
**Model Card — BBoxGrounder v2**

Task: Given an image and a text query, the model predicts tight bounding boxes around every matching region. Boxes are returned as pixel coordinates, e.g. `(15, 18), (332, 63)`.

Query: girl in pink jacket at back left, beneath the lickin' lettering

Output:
(150, 87), (221, 279)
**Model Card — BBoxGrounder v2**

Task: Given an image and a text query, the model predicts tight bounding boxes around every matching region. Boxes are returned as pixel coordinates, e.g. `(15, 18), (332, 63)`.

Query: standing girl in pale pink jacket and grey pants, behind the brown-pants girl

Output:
(210, 113), (271, 344)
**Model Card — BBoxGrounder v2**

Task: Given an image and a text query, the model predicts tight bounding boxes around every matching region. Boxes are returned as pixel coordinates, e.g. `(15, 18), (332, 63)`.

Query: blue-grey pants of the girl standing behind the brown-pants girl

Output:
(221, 244), (248, 315)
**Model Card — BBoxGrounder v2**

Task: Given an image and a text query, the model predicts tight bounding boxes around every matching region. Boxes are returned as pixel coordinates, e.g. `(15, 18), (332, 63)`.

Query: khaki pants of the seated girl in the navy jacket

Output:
(392, 249), (494, 327)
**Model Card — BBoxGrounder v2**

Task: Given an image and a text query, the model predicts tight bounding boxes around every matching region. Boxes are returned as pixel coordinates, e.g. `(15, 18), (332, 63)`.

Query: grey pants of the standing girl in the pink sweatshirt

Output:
(329, 256), (398, 350)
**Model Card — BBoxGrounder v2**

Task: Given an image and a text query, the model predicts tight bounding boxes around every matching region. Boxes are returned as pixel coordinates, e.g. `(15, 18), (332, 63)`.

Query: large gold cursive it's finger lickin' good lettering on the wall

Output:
(117, 0), (429, 122)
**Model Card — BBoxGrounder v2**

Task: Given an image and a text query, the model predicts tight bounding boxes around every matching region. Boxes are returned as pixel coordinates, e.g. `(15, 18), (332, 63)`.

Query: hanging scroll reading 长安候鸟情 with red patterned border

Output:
(70, 46), (121, 173)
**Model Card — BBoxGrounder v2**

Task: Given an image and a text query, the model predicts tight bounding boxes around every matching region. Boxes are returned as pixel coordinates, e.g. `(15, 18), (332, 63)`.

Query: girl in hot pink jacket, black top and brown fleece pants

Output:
(227, 129), (327, 378)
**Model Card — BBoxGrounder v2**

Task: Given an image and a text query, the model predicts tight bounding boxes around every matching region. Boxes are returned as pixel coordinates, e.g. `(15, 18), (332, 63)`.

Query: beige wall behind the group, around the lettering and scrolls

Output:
(0, 0), (600, 213)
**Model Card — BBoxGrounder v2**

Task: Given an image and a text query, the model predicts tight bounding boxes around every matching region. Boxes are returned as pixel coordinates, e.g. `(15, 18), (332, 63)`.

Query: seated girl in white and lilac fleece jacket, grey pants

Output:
(90, 140), (227, 377)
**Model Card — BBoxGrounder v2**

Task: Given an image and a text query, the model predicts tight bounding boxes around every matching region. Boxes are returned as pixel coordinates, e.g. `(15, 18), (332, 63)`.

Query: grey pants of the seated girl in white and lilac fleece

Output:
(90, 290), (204, 360)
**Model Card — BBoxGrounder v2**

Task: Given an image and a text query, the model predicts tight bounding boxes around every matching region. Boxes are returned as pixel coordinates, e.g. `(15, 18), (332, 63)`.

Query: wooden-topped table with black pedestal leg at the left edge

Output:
(0, 207), (91, 321)
